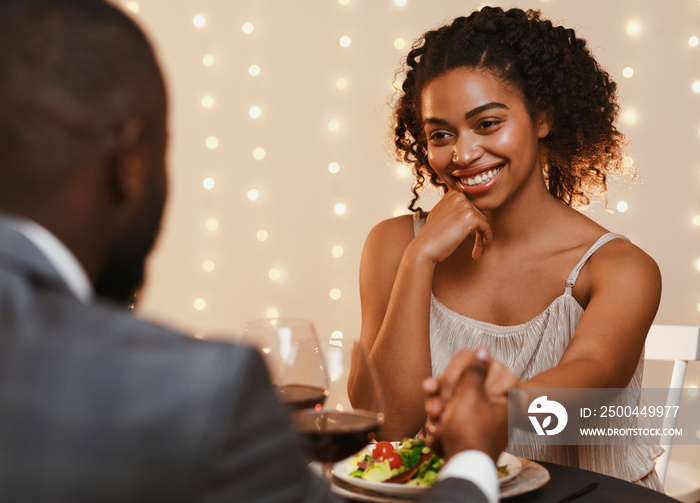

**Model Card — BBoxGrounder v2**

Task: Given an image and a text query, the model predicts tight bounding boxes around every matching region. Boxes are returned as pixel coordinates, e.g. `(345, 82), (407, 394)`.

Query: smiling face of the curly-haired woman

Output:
(421, 68), (550, 210)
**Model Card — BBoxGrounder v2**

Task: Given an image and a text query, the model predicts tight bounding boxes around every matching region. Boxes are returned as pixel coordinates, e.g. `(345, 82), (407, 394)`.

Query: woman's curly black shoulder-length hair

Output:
(394, 7), (631, 213)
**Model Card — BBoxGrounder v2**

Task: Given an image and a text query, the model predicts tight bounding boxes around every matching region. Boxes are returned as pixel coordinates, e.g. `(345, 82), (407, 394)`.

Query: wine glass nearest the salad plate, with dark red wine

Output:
(292, 342), (384, 483)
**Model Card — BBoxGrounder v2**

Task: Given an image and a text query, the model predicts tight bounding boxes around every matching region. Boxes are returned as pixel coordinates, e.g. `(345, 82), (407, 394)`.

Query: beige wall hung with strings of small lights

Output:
(118, 0), (700, 466)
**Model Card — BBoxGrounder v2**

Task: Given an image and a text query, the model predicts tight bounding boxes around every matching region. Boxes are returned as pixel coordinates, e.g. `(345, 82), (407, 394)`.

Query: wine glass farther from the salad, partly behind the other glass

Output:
(243, 318), (328, 411)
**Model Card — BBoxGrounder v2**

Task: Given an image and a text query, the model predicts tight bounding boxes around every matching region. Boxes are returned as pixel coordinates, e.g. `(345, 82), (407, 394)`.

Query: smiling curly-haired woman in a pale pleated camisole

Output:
(348, 8), (661, 490)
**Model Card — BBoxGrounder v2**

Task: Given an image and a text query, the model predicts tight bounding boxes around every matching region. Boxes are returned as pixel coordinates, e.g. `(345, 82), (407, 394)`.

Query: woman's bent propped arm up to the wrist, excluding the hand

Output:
(348, 217), (433, 439)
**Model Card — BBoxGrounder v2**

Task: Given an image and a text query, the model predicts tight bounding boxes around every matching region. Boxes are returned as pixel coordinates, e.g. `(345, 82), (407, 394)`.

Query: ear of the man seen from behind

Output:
(106, 118), (148, 205)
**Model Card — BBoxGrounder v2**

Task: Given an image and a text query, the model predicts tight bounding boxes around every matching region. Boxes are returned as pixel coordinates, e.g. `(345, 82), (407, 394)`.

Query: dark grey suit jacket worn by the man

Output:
(0, 218), (486, 503)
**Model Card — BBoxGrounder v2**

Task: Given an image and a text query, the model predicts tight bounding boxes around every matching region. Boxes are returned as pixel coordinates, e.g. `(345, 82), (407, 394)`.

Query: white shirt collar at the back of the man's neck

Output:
(7, 216), (93, 304)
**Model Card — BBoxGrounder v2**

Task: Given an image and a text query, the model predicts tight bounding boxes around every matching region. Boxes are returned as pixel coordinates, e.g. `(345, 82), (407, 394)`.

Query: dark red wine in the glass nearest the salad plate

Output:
(292, 410), (381, 466)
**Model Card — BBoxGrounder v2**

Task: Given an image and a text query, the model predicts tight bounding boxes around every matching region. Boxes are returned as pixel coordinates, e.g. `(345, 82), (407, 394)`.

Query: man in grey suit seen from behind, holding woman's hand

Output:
(0, 0), (505, 502)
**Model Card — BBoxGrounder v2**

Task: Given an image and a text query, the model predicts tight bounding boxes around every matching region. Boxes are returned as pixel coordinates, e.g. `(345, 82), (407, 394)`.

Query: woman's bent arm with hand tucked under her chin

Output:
(348, 192), (491, 439)
